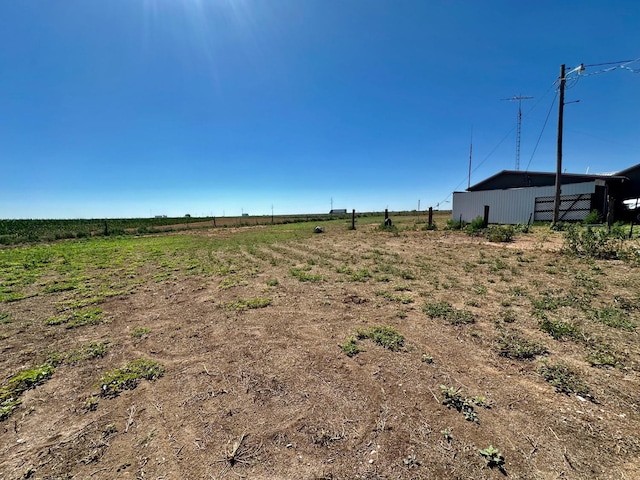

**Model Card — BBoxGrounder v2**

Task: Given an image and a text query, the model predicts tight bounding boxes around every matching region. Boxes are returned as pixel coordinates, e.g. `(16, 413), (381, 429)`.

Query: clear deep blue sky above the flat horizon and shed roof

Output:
(0, 0), (640, 218)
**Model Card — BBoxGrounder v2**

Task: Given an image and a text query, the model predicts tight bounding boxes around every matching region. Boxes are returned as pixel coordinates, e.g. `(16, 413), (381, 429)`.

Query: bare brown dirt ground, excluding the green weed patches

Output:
(0, 225), (640, 480)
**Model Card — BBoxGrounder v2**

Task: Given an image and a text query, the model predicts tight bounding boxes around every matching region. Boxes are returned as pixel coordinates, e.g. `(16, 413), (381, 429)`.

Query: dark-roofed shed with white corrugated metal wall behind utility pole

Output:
(451, 164), (640, 224)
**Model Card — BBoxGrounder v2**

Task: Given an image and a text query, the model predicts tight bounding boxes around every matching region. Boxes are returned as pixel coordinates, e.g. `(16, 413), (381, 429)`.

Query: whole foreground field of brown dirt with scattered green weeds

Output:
(0, 216), (640, 480)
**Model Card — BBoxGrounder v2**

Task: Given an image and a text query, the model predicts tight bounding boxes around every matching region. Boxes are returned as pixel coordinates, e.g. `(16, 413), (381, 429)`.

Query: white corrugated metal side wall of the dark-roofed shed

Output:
(451, 182), (596, 224)
